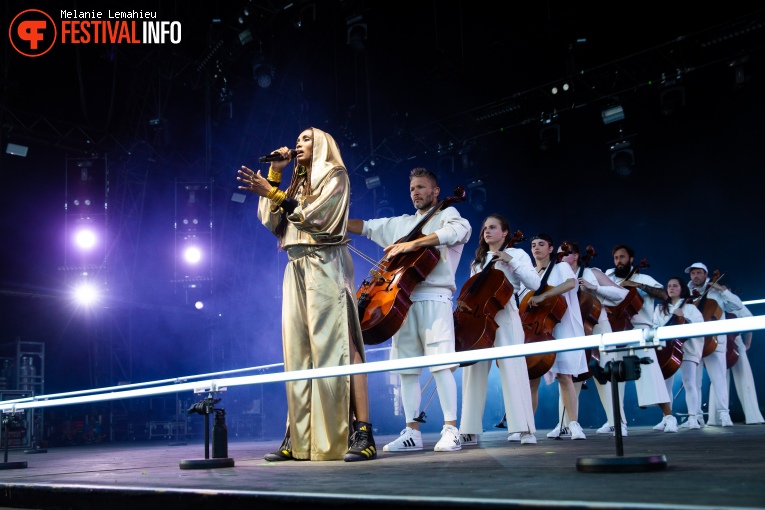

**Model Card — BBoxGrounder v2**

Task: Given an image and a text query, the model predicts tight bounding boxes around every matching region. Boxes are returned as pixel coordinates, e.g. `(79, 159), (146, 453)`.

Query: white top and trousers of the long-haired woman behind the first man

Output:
(460, 248), (540, 434)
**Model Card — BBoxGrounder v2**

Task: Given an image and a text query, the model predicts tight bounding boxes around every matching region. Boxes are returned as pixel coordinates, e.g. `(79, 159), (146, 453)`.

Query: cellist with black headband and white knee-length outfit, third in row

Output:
(523, 234), (587, 439)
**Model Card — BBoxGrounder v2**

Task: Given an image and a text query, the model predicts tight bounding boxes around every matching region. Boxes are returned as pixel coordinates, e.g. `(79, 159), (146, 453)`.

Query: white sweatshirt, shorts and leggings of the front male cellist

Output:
(361, 207), (471, 423)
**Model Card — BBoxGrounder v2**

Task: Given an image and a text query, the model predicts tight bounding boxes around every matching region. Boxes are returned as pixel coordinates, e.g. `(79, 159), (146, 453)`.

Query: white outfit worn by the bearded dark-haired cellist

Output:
(604, 268), (670, 407)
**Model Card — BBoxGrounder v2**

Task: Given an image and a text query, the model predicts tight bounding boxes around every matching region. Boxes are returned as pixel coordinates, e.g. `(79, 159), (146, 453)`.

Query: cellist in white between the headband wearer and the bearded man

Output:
(559, 241), (628, 436)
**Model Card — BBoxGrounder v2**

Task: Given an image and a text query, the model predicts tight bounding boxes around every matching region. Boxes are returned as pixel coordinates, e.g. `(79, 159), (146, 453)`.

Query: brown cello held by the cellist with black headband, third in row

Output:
(518, 243), (571, 379)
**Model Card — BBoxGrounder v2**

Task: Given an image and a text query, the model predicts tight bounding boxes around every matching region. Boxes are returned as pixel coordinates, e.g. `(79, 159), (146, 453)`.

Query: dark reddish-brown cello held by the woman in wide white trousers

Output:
(453, 230), (526, 366)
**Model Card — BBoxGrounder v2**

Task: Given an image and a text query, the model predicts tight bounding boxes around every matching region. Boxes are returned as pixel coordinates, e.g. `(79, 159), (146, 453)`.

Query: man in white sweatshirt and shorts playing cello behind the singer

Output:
(348, 168), (471, 452)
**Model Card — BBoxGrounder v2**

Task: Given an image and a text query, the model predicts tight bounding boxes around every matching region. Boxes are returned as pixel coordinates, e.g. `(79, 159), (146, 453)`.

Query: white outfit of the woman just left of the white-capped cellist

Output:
(653, 299), (704, 415)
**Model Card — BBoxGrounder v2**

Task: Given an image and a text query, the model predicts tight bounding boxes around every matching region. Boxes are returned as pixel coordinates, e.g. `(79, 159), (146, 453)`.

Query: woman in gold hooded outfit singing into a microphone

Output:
(237, 128), (377, 461)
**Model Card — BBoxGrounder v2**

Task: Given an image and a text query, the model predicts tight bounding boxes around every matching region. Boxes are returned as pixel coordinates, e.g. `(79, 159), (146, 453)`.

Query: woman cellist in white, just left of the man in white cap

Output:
(653, 277), (704, 432)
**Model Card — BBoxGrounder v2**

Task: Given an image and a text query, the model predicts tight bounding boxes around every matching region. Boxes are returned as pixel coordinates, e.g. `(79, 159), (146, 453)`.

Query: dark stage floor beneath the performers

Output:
(0, 424), (765, 510)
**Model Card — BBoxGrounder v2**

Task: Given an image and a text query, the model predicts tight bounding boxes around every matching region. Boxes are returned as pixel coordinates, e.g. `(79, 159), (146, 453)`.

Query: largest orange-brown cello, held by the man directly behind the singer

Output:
(356, 186), (466, 345)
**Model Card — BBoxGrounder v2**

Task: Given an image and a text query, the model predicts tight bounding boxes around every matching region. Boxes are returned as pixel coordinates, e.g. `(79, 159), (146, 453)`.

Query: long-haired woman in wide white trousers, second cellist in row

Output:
(460, 214), (540, 445)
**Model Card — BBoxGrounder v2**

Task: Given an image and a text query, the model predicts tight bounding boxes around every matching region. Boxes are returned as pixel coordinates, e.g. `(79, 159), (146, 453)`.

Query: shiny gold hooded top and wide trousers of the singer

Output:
(258, 128), (364, 460)
